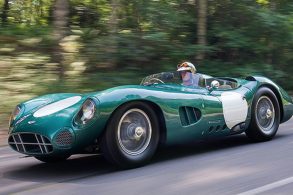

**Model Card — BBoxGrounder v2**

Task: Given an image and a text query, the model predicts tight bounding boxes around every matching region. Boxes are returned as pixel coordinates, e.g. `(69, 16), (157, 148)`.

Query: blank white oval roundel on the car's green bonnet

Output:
(34, 96), (81, 118)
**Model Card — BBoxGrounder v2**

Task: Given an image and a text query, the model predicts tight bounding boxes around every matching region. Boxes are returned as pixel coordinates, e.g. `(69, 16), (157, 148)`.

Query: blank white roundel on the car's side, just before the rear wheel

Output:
(220, 92), (248, 129)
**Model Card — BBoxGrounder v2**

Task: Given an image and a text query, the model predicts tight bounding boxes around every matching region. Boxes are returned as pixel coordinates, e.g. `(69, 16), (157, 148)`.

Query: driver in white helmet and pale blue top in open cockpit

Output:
(177, 62), (201, 86)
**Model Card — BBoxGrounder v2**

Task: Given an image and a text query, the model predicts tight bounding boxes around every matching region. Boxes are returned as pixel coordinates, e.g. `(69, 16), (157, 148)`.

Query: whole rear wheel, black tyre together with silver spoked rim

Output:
(245, 87), (281, 142)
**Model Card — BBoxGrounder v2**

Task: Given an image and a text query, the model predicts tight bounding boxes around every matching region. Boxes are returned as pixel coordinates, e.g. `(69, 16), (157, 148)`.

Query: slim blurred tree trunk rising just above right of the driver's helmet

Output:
(196, 0), (208, 61)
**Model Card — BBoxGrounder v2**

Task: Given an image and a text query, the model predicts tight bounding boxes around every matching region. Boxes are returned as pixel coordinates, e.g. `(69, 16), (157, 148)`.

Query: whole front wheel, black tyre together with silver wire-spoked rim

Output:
(101, 102), (160, 168)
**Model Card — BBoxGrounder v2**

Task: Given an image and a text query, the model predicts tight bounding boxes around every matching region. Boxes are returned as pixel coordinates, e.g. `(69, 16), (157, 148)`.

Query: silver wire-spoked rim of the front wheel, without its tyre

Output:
(117, 108), (152, 155)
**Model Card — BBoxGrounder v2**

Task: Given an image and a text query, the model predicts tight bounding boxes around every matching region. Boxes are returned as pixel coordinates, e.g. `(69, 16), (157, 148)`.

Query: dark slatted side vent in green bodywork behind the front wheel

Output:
(179, 106), (201, 126)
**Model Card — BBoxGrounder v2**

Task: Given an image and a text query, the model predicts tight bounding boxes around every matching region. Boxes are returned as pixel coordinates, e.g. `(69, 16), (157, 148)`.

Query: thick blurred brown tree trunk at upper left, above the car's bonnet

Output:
(52, 0), (69, 80)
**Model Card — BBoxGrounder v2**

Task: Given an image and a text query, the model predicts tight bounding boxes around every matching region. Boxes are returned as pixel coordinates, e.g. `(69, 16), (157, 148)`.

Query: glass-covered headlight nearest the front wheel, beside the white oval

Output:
(75, 99), (96, 125)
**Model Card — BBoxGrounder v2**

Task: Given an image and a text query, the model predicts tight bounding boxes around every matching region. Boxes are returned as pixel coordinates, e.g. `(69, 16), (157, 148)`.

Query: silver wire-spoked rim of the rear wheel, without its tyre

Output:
(256, 96), (275, 134)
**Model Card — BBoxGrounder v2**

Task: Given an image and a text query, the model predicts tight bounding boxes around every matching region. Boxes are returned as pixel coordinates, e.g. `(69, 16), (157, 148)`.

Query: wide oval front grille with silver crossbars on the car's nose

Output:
(8, 133), (53, 154)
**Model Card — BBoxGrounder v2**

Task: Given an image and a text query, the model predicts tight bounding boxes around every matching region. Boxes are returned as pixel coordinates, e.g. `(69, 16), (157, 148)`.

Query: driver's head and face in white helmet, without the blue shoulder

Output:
(177, 62), (196, 86)
